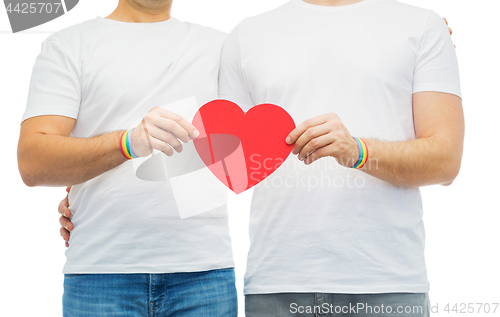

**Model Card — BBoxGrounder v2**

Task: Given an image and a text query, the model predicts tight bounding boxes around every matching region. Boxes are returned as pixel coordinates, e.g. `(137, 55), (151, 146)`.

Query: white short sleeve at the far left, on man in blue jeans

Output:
(23, 36), (81, 121)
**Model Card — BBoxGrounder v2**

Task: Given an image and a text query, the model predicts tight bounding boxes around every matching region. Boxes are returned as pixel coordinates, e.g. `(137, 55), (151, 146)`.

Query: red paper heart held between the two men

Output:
(193, 100), (295, 194)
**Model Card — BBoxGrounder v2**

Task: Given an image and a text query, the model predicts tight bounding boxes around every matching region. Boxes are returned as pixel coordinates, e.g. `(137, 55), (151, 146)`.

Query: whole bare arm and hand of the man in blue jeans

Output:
(17, 107), (199, 186)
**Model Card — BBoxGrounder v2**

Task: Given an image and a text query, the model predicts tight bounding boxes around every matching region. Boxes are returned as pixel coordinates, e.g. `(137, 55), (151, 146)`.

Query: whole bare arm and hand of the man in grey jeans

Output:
(287, 92), (464, 187)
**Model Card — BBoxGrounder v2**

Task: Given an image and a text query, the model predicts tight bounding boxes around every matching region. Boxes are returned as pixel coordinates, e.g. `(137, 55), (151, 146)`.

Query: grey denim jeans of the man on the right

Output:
(245, 293), (430, 317)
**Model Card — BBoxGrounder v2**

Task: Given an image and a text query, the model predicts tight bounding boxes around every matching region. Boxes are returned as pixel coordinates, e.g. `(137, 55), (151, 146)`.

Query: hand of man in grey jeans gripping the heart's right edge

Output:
(286, 113), (359, 167)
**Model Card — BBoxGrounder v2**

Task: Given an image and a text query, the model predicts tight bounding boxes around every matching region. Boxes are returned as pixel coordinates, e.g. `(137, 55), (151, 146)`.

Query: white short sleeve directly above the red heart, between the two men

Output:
(219, 26), (255, 111)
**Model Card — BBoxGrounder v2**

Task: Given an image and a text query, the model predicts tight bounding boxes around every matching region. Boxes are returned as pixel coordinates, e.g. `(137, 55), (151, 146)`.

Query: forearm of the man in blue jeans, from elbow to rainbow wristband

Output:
(18, 131), (126, 186)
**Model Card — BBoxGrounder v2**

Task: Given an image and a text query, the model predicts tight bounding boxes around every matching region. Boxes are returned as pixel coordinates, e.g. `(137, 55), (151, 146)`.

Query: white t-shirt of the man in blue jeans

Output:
(23, 18), (234, 273)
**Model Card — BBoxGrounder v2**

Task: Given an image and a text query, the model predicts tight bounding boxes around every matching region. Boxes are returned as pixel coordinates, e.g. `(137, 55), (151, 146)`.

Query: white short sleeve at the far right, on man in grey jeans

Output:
(413, 11), (462, 97)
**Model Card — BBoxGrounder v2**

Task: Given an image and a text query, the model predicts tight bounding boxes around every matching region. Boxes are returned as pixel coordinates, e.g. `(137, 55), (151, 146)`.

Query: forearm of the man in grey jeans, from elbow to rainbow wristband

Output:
(362, 135), (462, 187)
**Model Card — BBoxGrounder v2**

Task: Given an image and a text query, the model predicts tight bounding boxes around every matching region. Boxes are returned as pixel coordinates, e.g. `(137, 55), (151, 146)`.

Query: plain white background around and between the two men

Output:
(0, 0), (500, 316)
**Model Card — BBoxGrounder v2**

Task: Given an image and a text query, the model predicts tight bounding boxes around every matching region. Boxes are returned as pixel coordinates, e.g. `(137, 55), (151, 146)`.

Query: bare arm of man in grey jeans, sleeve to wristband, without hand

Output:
(362, 92), (465, 187)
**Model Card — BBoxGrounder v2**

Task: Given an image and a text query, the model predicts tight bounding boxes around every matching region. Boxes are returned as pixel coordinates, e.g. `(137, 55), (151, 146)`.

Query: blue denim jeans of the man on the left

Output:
(63, 268), (238, 317)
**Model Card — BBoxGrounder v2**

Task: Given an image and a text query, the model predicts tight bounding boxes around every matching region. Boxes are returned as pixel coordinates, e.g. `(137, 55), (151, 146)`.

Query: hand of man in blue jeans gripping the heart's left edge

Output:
(132, 107), (200, 157)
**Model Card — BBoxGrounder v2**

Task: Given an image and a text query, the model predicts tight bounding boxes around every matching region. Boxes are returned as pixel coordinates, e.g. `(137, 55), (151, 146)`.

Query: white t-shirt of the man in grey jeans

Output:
(219, 0), (460, 294)
